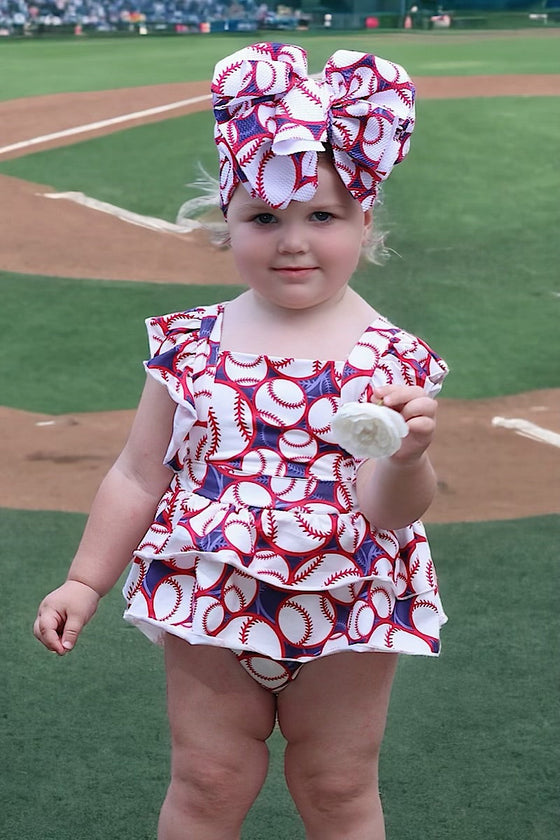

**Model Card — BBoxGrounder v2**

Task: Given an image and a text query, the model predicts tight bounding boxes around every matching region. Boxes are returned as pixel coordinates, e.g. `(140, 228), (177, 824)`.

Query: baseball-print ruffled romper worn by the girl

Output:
(123, 304), (447, 692)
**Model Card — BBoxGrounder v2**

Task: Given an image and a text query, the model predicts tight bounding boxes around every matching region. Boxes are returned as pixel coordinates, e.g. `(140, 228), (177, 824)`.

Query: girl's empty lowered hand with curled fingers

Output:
(33, 580), (100, 656)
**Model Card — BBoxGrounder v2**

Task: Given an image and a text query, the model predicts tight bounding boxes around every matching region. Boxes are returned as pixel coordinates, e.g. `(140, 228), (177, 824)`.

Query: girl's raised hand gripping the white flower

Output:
(372, 385), (437, 463)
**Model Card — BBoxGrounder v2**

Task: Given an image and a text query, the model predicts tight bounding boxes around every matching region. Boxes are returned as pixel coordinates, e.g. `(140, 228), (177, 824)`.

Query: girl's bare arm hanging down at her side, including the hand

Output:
(33, 377), (176, 655)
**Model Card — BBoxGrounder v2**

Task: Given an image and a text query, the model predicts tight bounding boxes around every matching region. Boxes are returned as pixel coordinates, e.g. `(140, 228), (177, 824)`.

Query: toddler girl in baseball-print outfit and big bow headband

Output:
(35, 44), (447, 840)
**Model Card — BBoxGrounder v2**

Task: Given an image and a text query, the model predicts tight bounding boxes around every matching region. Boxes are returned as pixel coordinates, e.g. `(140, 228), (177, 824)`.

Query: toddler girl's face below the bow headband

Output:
(227, 156), (371, 309)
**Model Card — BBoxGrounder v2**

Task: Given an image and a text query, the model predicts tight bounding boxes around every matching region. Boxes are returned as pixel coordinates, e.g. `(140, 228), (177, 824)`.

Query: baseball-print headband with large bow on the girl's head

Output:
(212, 43), (414, 215)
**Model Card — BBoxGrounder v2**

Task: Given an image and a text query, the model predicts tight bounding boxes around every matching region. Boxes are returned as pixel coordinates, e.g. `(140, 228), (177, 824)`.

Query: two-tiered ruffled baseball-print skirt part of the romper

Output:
(123, 477), (446, 663)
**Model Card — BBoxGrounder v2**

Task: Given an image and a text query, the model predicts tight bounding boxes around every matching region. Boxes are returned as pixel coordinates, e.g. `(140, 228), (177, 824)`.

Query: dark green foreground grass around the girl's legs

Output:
(0, 511), (560, 840)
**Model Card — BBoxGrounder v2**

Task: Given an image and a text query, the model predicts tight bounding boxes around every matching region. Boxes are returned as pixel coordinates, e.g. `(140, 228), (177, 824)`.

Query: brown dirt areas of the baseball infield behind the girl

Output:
(0, 76), (560, 522)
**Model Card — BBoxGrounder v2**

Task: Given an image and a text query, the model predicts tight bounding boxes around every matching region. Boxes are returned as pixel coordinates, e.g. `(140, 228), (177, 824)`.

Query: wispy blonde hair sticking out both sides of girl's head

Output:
(176, 165), (390, 265)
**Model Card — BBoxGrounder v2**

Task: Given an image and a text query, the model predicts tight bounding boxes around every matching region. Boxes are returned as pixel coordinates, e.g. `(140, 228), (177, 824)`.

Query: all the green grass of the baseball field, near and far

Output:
(0, 27), (560, 840)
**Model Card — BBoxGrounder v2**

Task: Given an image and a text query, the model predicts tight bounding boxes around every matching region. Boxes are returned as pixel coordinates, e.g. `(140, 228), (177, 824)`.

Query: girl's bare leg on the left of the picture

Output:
(158, 635), (276, 840)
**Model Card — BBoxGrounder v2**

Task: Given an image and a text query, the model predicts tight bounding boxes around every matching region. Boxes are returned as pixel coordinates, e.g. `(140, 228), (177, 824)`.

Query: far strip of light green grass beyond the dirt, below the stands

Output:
(0, 27), (560, 100)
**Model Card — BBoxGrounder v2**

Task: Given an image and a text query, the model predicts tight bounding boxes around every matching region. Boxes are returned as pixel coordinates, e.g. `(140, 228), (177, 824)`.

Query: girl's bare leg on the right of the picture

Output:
(277, 651), (397, 840)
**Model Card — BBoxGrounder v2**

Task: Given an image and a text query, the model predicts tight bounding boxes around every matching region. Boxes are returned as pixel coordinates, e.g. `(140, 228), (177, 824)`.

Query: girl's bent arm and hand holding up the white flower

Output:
(356, 385), (437, 530)
